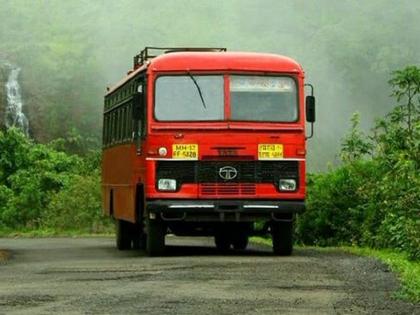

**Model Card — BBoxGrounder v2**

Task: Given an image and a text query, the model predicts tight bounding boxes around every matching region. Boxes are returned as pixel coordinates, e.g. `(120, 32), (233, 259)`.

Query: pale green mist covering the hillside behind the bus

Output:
(0, 0), (420, 170)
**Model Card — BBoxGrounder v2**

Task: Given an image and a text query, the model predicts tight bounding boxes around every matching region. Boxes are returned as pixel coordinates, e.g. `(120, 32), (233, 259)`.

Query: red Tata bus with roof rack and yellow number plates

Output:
(102, 47), (315, 255)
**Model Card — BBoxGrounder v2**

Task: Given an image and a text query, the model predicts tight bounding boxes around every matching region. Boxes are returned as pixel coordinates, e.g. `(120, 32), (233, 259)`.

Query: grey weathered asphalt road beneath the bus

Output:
(0, 237), (420, 315)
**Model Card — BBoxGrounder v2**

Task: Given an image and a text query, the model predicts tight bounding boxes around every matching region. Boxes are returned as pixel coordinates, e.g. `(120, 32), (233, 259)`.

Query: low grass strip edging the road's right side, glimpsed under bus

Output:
(251, 237), (420, 303)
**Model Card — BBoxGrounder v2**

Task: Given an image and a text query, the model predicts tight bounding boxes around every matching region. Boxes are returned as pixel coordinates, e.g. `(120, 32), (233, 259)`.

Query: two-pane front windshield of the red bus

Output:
(155, 75), (298, 122)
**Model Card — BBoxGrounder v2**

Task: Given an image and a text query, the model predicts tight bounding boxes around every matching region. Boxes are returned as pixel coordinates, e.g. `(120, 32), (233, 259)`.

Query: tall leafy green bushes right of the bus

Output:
(296, 66), (420, 260)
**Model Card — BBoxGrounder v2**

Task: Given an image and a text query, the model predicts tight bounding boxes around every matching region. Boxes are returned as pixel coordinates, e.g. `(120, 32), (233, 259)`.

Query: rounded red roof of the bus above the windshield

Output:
(106, 51), (303, 95)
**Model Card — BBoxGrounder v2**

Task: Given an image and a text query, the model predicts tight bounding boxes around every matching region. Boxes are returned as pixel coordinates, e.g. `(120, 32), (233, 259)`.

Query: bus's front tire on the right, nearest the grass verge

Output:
(271, 221), (293, 256)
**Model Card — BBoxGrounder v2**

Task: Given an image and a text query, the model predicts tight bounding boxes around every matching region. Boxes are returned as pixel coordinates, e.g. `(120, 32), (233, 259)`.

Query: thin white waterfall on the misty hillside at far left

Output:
(5, 64), (29, 135)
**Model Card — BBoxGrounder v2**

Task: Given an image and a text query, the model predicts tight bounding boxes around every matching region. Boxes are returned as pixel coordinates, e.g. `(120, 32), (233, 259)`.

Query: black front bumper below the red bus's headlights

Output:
(146, 199), (305, 222)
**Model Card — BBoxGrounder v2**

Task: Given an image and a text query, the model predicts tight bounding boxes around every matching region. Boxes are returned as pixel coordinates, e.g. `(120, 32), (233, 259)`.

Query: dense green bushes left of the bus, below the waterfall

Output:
(0, 128), (110, 235)
